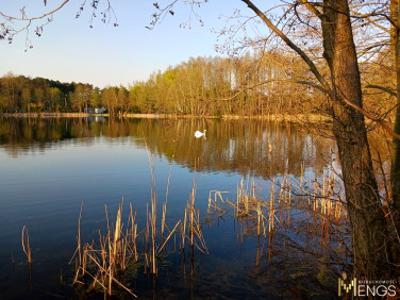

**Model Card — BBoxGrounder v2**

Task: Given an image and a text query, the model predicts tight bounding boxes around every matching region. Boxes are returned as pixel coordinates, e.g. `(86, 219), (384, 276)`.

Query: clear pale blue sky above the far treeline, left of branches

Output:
(0, 0), (276, 87)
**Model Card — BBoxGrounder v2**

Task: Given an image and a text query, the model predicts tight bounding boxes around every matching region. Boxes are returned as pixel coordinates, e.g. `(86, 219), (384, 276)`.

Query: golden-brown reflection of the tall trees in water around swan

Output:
(133, 120), (332, 176)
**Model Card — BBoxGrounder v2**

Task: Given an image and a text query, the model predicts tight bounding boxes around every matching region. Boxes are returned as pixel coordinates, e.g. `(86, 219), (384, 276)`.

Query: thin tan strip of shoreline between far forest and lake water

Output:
(0, 112), (331, 123)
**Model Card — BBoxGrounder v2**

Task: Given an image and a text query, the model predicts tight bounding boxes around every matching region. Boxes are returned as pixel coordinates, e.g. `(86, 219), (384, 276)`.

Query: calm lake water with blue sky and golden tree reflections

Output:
(0, 118), (342, 299)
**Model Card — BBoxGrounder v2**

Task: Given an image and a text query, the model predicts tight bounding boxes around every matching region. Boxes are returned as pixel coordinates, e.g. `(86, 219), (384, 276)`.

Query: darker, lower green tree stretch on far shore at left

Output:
(0, 74), (128, 113)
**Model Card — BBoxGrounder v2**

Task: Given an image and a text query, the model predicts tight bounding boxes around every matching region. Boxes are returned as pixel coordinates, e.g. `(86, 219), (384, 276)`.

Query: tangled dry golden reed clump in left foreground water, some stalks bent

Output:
(71, 187), (208, 297)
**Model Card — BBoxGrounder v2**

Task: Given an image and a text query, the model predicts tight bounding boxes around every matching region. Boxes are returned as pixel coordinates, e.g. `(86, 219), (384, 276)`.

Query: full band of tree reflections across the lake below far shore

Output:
(0, 118), (333, 177)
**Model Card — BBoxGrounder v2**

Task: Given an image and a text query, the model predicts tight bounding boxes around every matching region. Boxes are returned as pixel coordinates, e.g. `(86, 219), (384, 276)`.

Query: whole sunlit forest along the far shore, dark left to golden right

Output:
(0, 52), (393, 116)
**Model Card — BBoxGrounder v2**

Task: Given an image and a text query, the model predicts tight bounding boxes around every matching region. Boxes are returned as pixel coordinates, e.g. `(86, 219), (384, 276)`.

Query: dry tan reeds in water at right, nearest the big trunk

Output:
(203, 170), (347, 245)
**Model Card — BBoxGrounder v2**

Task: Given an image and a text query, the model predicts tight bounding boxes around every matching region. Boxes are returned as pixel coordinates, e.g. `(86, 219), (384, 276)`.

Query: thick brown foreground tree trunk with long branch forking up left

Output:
(242, 0), (395, 280)
